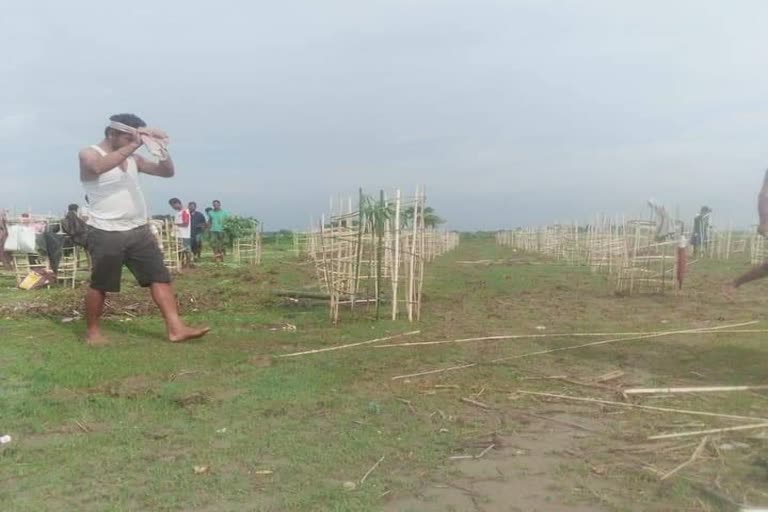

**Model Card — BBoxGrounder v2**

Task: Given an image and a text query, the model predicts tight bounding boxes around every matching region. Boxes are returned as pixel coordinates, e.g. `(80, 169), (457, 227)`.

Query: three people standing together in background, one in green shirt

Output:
(168, 197), (229, 266)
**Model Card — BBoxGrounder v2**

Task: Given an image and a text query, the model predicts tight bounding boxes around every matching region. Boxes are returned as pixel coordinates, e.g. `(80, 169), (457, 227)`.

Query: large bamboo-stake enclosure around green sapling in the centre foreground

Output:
(302, 187), (459, 323)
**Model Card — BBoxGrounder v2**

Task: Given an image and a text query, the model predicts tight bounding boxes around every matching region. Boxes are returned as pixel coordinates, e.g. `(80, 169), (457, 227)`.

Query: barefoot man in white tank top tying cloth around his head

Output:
(80, 114), (208, 345)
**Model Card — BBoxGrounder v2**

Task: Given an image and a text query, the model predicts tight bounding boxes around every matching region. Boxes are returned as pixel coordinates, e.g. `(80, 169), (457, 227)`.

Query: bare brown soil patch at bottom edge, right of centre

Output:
(383, 412), (609, 512)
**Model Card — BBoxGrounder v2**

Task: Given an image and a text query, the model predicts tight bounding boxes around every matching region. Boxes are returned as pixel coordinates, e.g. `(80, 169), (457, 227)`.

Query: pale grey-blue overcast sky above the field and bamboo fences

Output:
(0, 0), (768, 229)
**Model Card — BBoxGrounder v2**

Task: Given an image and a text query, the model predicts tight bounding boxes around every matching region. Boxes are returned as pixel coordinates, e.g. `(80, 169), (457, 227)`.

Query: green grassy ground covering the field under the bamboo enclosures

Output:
(0, 238), (768, 511)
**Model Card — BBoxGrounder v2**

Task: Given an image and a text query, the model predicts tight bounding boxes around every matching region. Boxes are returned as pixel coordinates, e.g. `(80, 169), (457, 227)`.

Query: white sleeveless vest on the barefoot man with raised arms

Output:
(81, 146), (148, 231)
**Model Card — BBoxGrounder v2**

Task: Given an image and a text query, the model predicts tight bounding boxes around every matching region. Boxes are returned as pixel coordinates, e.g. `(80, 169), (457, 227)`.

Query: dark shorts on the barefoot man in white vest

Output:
(88, 225), (171, 292)
